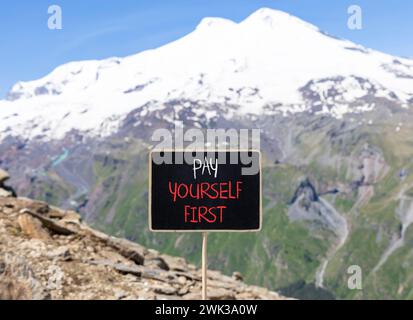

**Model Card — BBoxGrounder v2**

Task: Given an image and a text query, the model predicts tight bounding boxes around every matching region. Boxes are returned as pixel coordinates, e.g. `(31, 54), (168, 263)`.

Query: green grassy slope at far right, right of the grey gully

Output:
(326, 126), (413, 299)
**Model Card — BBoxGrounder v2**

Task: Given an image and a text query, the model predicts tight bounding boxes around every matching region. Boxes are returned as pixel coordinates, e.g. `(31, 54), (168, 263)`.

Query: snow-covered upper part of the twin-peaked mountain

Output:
(0, 9), (413, 139)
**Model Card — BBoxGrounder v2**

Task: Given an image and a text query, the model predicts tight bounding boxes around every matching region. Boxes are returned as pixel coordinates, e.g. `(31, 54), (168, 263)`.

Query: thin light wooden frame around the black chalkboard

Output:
(148, 149), (262, 233)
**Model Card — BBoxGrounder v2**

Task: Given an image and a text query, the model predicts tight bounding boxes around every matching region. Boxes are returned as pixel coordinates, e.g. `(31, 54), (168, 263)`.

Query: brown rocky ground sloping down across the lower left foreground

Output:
(0, 170), (284, 299)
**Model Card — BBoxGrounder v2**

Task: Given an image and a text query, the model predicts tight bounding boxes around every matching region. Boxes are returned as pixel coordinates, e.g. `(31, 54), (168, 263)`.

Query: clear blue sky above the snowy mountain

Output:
(0, 0), (413, 98)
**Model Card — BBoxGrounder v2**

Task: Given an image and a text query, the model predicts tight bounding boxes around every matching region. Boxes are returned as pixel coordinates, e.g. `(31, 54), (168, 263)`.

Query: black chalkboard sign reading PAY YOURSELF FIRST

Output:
(149, 151), (261, 231)
